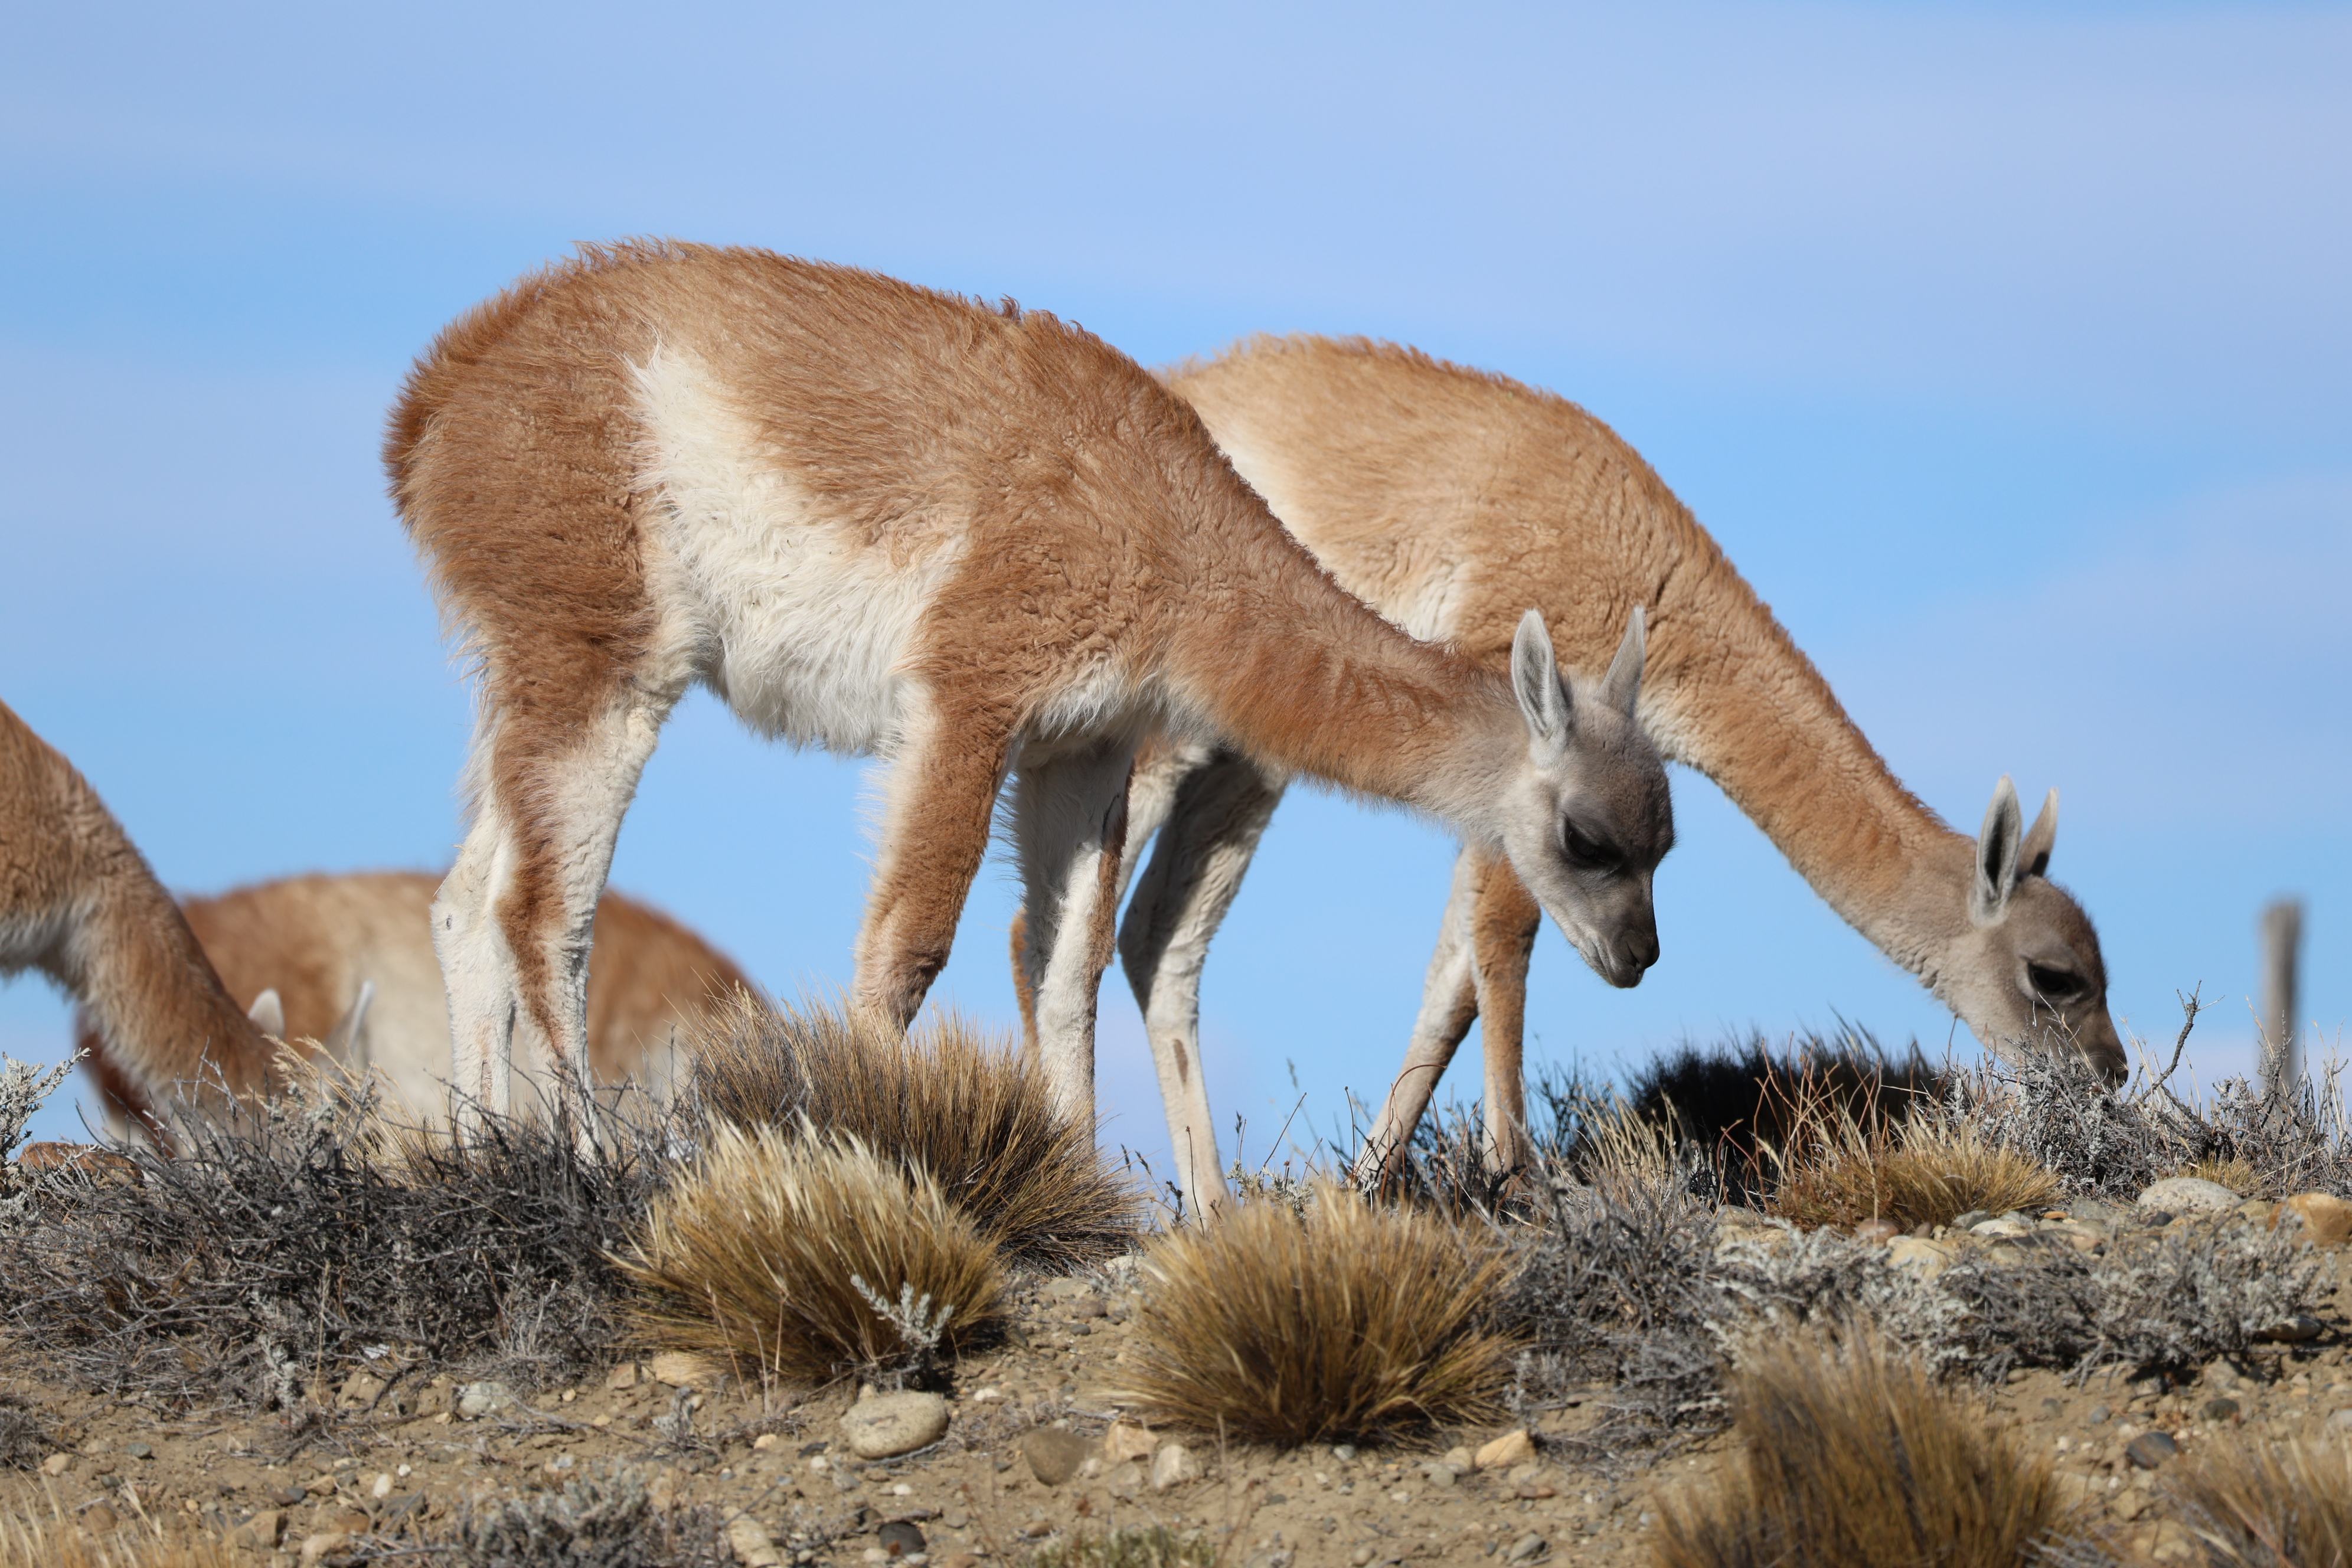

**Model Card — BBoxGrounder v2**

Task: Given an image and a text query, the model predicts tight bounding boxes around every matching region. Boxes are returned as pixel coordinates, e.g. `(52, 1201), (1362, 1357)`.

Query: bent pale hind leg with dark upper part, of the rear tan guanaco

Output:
(1119, 750), (1284, 1218)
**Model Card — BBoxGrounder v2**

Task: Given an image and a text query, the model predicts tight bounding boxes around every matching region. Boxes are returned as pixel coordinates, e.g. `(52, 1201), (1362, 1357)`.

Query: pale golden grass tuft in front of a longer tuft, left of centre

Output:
(616, 1126), (1004, 1382)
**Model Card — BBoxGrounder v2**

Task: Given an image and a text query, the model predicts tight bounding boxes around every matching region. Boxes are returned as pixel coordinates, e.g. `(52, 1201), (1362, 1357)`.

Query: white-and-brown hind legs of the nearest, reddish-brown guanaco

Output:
(433, 682), (680, 1116)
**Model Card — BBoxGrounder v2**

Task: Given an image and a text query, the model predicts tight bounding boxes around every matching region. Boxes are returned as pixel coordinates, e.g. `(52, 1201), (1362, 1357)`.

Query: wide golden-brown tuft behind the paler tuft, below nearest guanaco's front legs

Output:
(694, 994), (1143, 1269)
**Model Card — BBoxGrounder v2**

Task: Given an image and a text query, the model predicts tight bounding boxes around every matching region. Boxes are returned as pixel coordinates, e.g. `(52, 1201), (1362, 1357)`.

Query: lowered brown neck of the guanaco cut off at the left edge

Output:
(45, 780), (268, 1114)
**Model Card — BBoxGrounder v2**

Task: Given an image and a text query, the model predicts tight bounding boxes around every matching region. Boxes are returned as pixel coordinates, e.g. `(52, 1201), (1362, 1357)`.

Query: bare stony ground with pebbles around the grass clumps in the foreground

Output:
(0, 1190), (2352, 1568)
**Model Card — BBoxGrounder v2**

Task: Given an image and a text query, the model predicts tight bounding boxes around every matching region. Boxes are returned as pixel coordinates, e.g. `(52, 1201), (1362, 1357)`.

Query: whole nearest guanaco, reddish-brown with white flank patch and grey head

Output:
(386, 242), (1672, 1171)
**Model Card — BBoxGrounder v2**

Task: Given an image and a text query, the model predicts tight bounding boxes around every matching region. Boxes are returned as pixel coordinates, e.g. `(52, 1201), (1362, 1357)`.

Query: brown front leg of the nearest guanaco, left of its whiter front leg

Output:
(851, 719), (1011, 1030)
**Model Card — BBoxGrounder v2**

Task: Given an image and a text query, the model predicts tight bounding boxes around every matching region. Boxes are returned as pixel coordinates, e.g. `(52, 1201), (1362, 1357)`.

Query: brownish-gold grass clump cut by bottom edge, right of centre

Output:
(1651, 1328), (2065, 1568)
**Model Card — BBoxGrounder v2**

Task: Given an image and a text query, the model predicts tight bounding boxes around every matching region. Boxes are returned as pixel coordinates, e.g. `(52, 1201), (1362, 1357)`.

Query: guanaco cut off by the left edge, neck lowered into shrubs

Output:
(0, 703), (334, 1140)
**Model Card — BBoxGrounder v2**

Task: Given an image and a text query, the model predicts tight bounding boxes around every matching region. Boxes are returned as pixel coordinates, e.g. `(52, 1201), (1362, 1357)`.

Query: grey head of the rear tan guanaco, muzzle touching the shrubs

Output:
(1938, 773), (2131, 1084)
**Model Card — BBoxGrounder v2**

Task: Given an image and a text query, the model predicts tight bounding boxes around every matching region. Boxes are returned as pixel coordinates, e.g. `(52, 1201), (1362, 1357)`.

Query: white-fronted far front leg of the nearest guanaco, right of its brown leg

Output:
(1014, 745), (1133, 1126)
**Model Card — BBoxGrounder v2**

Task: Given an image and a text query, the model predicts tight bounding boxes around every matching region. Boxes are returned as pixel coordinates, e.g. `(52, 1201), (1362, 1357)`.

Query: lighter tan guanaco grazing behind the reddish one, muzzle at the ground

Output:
(1129, 336), (2124, 1171)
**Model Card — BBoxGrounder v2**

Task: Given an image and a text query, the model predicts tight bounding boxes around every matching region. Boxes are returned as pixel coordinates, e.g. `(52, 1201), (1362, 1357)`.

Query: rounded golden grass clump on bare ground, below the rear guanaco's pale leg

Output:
(1115, 1180), (1517, 1443)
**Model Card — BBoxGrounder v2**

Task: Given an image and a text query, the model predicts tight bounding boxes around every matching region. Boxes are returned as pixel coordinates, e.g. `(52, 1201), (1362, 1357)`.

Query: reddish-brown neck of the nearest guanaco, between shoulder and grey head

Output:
(1169, 482), (1527, 839)
